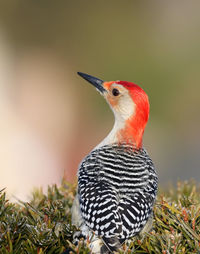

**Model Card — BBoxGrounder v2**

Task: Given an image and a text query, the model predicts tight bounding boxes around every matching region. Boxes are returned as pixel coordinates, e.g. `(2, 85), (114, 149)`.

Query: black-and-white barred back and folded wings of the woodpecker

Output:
(78, 144), (157, 251)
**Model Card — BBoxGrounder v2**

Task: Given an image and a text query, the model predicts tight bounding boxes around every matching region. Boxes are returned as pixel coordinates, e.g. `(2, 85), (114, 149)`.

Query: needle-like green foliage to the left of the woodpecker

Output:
(0, 186), (74, 254)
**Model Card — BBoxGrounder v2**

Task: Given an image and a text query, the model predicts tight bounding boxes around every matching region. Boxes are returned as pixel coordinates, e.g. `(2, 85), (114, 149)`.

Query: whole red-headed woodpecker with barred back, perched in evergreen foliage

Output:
(72, 72), (158, 253)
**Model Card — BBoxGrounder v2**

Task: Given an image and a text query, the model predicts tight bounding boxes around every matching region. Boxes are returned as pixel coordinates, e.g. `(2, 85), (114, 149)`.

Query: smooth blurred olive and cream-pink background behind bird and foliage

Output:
(0, 0), (200, 200)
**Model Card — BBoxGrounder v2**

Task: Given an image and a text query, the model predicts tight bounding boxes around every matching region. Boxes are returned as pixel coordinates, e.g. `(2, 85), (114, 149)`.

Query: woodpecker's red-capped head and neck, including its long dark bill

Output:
(78, 72), (149, 148)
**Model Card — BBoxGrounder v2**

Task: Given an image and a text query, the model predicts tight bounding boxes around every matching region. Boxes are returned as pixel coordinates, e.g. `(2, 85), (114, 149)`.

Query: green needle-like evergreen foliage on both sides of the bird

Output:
(0, 181), (200, 254)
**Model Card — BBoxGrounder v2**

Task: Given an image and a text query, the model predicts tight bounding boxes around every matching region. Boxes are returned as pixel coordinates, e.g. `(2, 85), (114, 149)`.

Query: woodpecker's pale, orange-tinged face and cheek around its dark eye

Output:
(104, 83), (135, 121)
